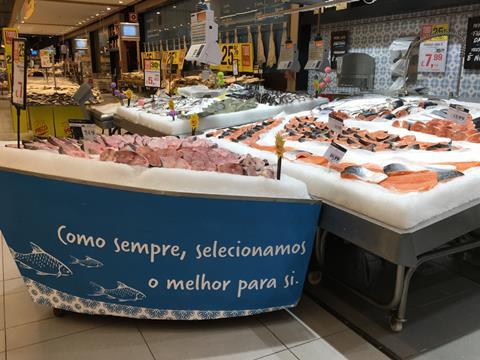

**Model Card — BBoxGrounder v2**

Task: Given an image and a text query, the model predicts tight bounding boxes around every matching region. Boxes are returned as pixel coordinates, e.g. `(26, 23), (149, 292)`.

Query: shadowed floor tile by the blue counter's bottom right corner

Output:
(291, 295), (347, 337)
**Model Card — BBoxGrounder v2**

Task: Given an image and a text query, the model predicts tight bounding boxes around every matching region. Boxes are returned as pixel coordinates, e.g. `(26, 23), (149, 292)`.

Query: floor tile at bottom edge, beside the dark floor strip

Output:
(324, 330), (389, 360)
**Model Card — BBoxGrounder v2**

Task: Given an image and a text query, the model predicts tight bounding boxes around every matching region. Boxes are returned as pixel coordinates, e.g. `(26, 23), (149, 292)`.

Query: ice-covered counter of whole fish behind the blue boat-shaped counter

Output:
(111, 85), (328, 135)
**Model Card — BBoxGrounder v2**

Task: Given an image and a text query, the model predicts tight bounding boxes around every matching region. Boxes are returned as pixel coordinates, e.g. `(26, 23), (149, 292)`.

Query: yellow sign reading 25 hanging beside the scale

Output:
(210, 43), (253, 73)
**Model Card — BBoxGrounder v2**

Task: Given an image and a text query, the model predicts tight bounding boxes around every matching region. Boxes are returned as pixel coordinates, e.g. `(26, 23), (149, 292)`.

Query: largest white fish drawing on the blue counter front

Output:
(10, 242), (73, 278)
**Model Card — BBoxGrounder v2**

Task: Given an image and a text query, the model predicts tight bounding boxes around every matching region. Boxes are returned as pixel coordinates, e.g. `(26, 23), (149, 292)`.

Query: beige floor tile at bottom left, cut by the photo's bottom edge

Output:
(8, 324), (153, 360)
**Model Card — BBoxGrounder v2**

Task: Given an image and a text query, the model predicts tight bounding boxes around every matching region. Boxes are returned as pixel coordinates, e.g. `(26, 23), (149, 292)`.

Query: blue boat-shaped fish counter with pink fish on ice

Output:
(0, 135), (320, 320)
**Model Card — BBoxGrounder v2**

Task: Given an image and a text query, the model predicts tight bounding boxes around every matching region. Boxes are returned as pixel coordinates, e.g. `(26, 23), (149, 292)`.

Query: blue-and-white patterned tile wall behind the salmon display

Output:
(309, 4), (480, 98)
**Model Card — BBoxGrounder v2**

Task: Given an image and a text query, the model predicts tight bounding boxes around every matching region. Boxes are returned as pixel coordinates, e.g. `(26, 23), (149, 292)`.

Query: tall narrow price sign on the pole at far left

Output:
(12, 38), (27, 110)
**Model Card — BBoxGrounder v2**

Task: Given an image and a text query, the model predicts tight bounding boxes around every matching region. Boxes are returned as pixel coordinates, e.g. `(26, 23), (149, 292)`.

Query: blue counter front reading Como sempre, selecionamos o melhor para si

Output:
(0, 170), (320, 320)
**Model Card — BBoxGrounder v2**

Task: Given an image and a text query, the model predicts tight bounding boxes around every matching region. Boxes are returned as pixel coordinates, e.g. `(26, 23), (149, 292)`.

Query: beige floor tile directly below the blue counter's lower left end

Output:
(7, 313), (111, 351)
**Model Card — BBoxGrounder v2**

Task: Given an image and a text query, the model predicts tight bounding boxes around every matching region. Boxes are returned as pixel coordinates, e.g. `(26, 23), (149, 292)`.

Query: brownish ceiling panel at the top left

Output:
(15, 0), (136, 35)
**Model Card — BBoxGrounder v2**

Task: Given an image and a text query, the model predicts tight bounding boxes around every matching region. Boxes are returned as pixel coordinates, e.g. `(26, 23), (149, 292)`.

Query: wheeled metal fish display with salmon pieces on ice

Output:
(205, 96), (480, 331)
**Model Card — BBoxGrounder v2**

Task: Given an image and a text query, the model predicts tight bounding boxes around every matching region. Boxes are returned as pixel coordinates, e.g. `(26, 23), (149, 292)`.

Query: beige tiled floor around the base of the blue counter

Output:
(0, 238), (388, 360)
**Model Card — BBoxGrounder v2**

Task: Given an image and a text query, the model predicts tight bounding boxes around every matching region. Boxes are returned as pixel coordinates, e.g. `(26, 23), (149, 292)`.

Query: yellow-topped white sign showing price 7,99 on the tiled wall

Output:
(418, 24), (448, 73)
